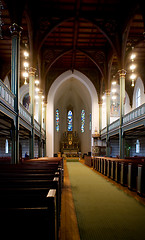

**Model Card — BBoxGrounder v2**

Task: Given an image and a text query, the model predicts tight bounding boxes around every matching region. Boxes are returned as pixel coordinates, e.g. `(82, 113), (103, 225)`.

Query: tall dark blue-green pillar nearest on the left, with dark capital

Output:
(10, 23), (22, 164)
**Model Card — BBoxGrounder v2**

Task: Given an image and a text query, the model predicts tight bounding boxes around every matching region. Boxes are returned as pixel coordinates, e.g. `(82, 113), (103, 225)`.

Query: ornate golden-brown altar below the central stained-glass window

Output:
(61, 131), (80, 157)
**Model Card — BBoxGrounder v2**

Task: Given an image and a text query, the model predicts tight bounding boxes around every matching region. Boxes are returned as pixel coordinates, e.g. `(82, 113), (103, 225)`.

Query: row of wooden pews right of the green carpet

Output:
(93, 157), (145, 197)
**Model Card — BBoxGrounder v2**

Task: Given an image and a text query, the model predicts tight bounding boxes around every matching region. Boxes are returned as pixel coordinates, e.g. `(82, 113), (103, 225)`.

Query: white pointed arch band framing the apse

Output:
(46, 70), (99, 157)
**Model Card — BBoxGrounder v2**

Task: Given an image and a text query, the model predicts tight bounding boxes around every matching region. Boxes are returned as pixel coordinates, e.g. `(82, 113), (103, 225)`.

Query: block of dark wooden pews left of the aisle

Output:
(0, 159), (62, 240)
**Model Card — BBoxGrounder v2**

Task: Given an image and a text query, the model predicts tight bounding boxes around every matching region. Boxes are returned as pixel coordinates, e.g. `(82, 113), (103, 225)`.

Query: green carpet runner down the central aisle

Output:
(67, 162), (145, 240)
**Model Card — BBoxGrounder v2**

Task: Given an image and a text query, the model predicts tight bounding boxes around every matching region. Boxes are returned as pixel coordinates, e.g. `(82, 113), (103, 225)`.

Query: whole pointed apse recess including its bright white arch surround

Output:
(46, 70), (99, 156)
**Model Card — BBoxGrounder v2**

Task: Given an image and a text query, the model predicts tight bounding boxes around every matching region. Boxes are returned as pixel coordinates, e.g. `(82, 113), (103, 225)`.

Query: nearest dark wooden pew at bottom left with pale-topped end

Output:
(0, 189), (58, 240)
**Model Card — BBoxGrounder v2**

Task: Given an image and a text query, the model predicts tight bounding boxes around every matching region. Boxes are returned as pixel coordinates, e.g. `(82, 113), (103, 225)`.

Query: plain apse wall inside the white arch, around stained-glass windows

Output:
(54, 78), (92, 153)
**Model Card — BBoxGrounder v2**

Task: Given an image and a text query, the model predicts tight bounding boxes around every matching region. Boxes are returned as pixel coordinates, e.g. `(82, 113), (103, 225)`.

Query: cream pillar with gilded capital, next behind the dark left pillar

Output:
(29, 67), (36, 158)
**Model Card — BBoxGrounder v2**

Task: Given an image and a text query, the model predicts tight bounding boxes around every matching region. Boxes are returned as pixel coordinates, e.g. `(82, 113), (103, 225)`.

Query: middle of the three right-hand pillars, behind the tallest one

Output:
(106, 90), (110, 157)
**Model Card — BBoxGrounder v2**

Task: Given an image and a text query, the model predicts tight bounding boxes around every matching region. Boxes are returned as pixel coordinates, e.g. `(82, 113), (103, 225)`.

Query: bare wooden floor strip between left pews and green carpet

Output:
(59, 161), (80, 240)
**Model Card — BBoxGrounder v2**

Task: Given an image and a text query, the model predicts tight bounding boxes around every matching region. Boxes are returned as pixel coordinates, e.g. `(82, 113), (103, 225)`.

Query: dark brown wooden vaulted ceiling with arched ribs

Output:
(0, 0), (145, 102)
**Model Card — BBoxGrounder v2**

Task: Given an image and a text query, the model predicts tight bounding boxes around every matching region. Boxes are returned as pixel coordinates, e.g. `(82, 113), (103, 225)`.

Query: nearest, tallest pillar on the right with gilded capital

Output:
(118, 69), (126, 158)
